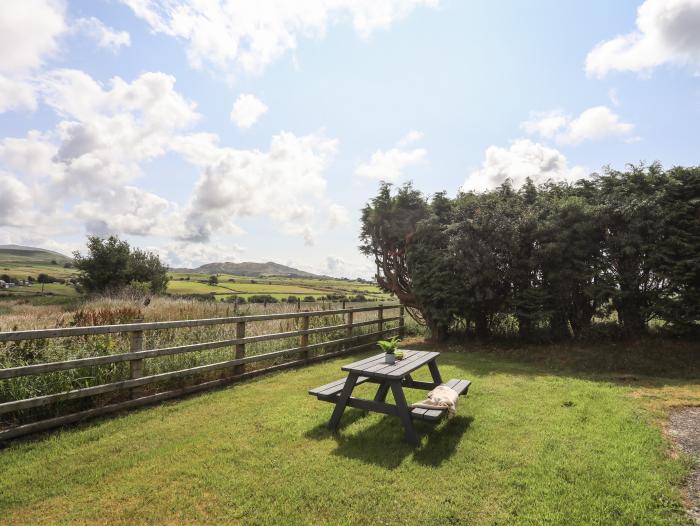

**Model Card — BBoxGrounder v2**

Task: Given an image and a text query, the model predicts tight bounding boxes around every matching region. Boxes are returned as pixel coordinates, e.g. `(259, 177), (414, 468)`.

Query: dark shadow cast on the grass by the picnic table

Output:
(305, 409), (474, 469)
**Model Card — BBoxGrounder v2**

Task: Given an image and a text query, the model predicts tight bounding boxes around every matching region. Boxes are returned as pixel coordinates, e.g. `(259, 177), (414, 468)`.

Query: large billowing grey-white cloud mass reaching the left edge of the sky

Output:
(0, 70), (199, 240)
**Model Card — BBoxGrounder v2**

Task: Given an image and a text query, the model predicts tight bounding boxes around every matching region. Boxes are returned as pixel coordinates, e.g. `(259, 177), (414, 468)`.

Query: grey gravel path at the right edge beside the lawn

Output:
(668, 407), (700, 525)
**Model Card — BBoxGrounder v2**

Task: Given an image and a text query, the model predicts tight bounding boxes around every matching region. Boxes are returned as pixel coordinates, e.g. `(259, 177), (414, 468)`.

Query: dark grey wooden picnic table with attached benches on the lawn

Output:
(309, 350), (471, 445)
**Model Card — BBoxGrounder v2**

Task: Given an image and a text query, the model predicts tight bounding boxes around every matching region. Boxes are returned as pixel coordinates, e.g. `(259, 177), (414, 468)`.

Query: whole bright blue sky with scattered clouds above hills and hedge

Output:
(0, 0), (700, 277)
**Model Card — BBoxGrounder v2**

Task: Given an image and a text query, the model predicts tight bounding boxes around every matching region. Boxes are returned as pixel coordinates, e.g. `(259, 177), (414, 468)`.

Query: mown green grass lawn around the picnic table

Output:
(0, 342), (700, 525)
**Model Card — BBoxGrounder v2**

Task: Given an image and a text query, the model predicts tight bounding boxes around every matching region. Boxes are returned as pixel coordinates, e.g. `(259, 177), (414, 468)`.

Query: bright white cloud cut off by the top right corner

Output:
(586, 0), (700, 78)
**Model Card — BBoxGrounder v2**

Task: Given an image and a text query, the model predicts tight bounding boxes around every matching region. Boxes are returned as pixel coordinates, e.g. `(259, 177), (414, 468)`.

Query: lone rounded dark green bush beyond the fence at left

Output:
(74, 236), (169, 294)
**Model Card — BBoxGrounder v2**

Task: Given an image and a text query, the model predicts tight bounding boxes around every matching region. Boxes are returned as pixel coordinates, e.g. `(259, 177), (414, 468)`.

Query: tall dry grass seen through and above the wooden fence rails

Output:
(0, 297), (398, 425)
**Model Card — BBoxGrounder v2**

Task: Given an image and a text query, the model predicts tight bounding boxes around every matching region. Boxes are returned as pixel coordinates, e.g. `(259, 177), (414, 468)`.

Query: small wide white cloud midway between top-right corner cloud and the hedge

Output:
(521, 106), (634, 144)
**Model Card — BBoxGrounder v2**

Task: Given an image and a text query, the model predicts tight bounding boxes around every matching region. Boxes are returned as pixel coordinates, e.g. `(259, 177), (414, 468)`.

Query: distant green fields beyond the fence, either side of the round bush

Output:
(0, 250), (391, 301)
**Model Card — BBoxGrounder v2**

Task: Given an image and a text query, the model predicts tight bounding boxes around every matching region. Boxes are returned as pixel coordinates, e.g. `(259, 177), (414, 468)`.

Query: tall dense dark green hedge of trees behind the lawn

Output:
(360, 164), (700, 339)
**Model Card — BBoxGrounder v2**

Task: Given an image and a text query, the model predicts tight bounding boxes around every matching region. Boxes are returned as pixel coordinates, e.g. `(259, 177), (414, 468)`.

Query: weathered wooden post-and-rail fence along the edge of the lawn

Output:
(0, 305), (404, 442)
